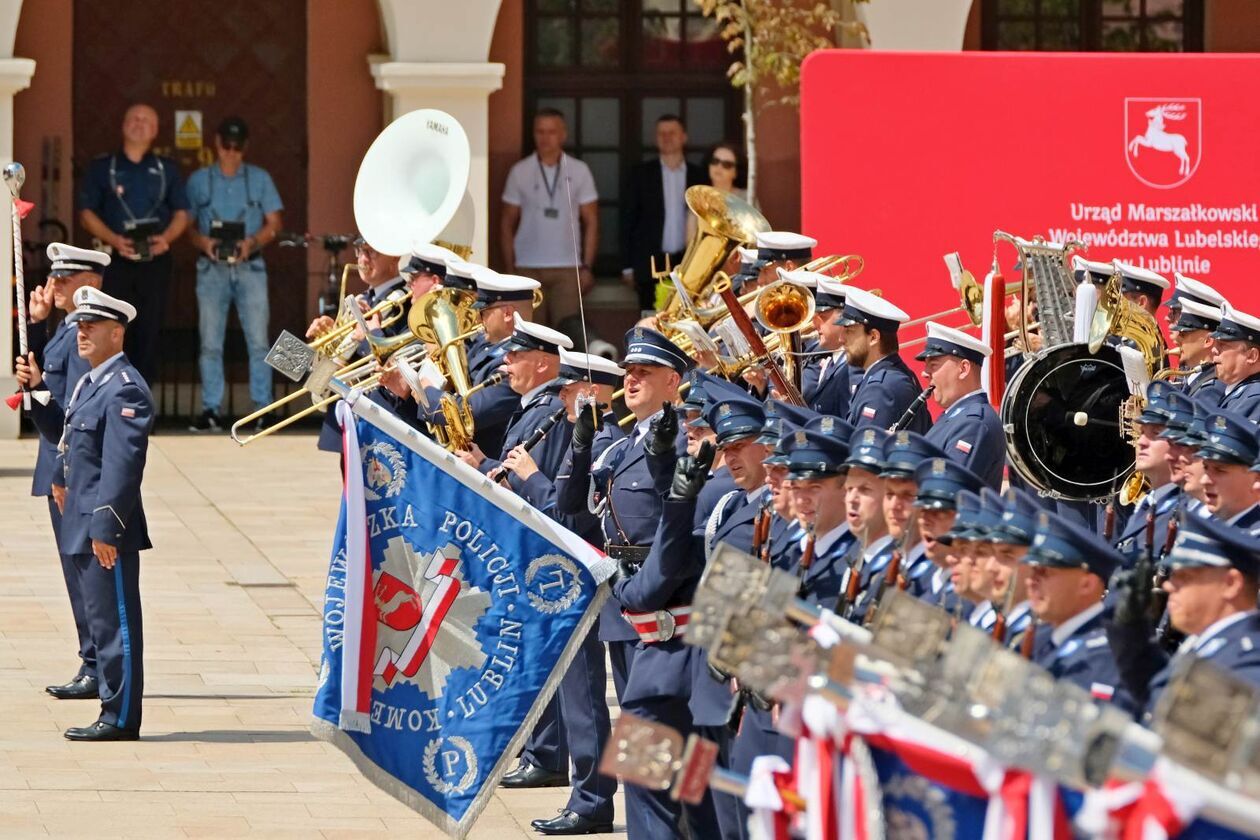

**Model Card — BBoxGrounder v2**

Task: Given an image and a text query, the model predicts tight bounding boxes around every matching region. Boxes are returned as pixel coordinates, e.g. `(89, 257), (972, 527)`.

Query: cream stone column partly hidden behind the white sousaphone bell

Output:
(372, 59), (504, 263)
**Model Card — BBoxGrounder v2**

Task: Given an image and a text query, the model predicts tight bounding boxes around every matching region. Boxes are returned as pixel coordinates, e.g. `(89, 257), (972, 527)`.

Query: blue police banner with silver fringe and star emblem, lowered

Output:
(311, 399), (612, 837)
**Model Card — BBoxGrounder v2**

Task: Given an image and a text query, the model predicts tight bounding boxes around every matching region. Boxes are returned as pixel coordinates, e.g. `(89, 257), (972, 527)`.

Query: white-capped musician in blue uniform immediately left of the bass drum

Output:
(915, 321), (1007, 490)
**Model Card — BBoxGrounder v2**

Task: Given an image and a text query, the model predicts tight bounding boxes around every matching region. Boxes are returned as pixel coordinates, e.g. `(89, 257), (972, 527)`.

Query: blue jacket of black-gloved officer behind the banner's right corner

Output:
(556, 417), (645, 642)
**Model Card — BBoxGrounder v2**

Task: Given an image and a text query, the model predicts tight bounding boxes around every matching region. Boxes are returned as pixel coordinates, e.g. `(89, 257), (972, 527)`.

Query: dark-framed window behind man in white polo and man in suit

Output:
(522, 0), (742, 275)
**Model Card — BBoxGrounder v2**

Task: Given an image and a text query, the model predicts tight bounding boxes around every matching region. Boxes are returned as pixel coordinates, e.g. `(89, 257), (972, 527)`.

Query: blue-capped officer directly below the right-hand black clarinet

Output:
(879, 432), (946, 593)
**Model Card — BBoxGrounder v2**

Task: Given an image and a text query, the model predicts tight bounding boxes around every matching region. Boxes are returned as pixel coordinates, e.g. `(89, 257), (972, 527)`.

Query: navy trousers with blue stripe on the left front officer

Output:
(71, 552), (145, 729)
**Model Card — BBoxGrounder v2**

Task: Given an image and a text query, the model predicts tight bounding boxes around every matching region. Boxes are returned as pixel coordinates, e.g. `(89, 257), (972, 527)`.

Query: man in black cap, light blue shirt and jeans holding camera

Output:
(188, 117), (284, 432)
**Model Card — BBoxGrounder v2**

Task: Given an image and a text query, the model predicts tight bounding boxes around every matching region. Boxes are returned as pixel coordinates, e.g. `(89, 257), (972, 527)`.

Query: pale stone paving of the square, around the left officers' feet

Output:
(0, 434), (624, 840)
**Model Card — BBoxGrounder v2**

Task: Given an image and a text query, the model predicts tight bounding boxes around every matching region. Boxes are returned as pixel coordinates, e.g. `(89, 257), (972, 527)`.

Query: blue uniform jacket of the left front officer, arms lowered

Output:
(33, 354), (154, 554)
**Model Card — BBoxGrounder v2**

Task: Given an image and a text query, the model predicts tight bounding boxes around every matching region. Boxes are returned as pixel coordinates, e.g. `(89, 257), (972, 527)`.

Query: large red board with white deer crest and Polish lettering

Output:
(801, 50), (1260, 315)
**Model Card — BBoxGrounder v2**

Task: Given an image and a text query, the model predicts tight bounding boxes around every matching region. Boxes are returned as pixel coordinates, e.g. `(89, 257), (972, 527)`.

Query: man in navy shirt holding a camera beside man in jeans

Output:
(79, 105), (188, 383)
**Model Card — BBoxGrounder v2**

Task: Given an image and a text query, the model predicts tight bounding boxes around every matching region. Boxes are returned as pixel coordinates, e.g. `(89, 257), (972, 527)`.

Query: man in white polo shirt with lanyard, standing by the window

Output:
(499, 108), (600, 326)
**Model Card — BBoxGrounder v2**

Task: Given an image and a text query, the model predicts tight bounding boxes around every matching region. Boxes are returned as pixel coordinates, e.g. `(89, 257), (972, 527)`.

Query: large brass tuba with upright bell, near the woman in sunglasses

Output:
(658, 186), (770, 324)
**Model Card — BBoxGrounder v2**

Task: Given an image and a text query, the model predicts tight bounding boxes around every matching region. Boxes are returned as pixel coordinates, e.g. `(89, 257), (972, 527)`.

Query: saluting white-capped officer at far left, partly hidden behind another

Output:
(18, 242), (110, 700)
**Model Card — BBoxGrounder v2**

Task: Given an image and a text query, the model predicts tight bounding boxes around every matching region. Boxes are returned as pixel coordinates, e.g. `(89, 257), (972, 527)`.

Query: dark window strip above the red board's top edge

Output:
(982, 0), (1203, 53)
